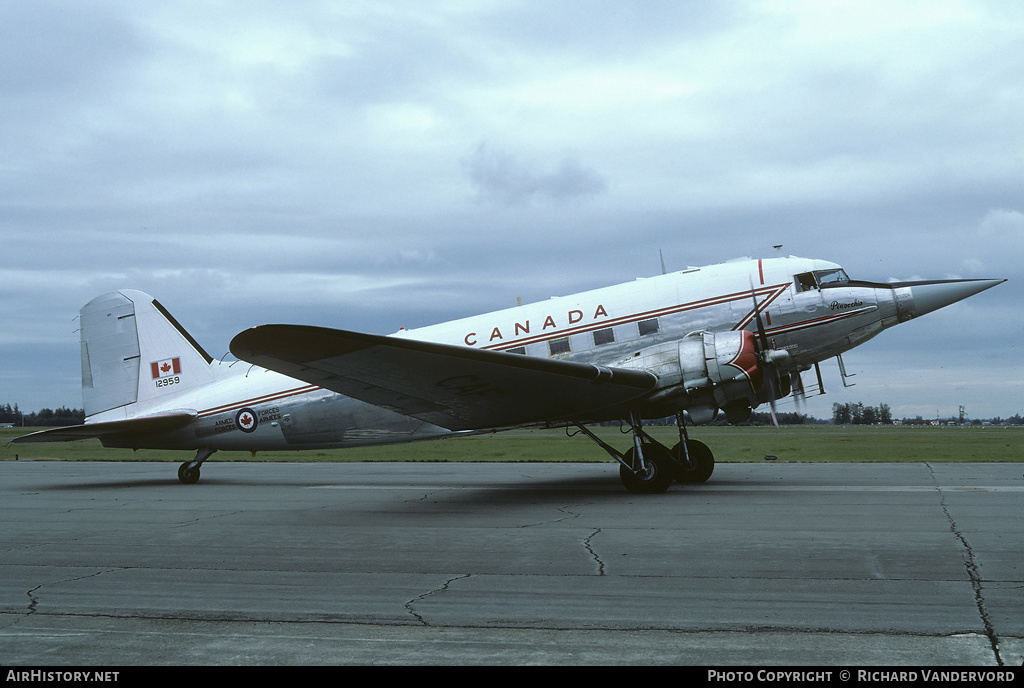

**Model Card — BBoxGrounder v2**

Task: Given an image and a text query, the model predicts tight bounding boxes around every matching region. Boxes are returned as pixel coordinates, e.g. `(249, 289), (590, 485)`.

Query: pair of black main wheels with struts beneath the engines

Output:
(575, 411), (715, 495)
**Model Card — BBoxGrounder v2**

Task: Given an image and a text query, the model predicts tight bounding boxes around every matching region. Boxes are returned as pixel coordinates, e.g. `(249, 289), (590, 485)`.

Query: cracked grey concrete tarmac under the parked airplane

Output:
(0, 460), (1024, 667)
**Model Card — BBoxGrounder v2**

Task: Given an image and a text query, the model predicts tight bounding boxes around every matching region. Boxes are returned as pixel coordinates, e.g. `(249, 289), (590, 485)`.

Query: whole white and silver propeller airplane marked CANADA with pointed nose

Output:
(14, 257), (1005, 492)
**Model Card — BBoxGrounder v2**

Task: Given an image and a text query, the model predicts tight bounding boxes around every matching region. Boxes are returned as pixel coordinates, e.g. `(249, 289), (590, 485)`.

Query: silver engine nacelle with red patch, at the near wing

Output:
(614, 330), (764, 423)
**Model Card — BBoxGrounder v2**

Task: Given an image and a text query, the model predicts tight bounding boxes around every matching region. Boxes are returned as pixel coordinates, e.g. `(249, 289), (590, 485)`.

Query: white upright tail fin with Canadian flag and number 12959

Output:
(81, 290), (213, 418)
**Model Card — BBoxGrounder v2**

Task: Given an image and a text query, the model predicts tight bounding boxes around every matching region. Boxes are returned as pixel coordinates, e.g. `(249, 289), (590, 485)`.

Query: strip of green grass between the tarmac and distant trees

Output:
(0, 425), (1024, 463)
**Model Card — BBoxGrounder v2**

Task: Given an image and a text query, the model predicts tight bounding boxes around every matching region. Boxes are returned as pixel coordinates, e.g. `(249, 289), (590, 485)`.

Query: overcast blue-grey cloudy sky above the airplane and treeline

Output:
(0, 0), (1024, 418)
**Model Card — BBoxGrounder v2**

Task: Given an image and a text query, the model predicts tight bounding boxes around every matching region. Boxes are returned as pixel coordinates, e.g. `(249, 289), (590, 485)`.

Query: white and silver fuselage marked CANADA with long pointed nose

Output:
(77, 257), (998, 452)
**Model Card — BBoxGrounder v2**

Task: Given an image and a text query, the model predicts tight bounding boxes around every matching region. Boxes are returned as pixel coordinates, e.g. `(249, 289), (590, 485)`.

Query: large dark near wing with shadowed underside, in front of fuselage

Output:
(230, 325), (656, 430)
